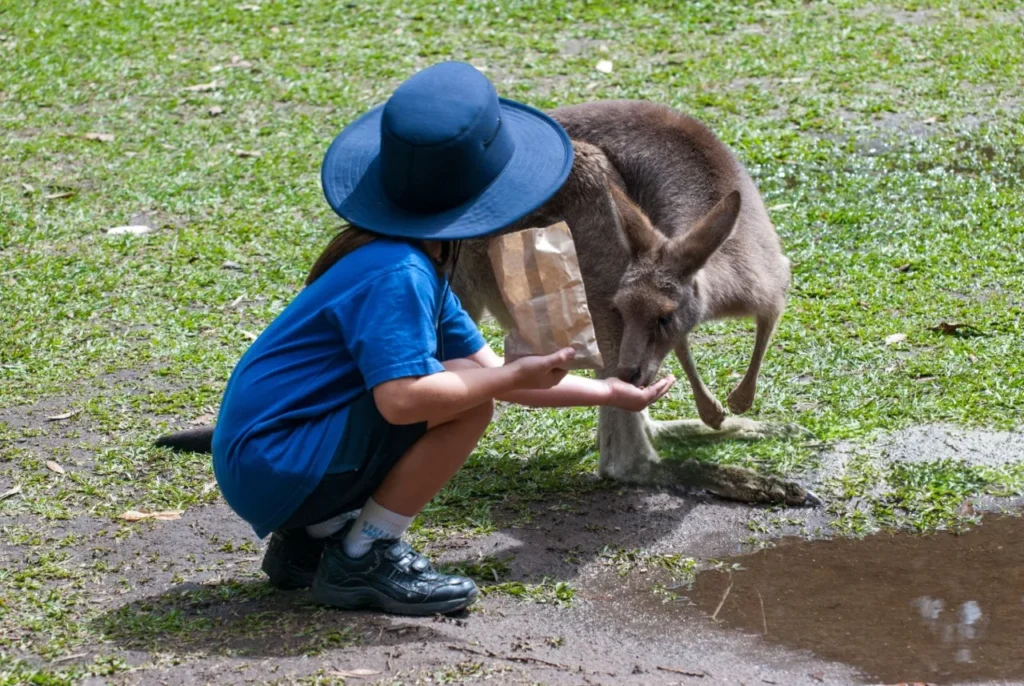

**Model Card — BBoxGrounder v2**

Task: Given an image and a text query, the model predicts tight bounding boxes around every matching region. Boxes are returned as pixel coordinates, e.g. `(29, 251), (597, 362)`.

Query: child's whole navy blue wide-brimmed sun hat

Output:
(321, 61), (572, 241)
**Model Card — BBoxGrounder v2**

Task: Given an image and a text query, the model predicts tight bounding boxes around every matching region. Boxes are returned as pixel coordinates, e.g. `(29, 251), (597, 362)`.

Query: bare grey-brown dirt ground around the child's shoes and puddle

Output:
(0, 393), (1024, 684)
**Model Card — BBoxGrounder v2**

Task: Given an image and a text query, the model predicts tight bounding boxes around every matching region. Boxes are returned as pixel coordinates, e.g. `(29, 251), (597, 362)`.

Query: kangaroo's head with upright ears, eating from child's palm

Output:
(612, 188), (739, 386)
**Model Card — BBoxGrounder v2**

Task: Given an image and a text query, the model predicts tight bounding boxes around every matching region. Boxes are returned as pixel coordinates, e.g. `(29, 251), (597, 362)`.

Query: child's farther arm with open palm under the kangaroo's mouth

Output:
(469, 345), (676, 412)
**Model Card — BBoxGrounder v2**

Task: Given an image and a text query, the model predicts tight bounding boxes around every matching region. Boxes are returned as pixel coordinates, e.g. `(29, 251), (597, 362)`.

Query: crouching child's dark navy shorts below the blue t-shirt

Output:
(281, 392), (427, 529)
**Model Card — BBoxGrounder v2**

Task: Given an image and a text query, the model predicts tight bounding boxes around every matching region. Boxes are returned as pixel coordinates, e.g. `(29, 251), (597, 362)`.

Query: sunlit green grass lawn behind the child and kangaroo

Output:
(0, 0), (1024, 683)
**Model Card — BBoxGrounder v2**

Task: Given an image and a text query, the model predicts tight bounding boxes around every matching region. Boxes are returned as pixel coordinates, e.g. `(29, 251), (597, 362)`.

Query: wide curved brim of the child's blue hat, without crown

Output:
(321, 98), (572, 241)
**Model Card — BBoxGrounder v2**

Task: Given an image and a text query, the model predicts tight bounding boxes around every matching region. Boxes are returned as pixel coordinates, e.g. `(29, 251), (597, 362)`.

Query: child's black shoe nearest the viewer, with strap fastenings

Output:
(312, 523), (477, 615)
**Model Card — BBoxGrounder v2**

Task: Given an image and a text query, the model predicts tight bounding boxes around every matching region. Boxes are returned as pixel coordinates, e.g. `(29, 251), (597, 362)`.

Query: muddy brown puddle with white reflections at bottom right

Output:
(671, 514), (1024, 683)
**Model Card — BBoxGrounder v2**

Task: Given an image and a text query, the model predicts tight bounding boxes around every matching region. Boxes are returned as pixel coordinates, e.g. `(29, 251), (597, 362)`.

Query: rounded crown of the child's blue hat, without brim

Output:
(380, 62), (515, 213)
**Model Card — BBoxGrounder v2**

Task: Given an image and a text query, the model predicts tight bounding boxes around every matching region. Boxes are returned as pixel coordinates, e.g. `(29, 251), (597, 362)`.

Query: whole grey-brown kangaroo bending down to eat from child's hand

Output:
(158, 101), (819, 505)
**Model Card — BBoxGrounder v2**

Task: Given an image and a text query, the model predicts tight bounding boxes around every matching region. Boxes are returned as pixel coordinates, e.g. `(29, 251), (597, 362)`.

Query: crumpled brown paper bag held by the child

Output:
(487, 221), (604, 369)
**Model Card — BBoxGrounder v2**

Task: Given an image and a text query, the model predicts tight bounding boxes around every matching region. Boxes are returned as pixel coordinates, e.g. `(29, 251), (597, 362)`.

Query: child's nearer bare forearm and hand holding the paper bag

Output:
(373, 348), (572, 425)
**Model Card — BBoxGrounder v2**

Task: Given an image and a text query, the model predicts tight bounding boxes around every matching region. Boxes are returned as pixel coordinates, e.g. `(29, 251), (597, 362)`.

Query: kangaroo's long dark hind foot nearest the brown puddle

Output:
(648, 460), (822, 507)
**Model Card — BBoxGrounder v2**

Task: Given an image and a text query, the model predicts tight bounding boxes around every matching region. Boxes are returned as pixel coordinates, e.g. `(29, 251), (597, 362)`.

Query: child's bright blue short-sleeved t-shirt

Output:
(213, 239), (484, 538)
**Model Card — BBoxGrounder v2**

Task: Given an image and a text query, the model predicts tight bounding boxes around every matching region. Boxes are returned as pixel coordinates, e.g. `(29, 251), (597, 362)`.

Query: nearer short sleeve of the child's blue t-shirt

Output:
(333, 266), (444, 389)
